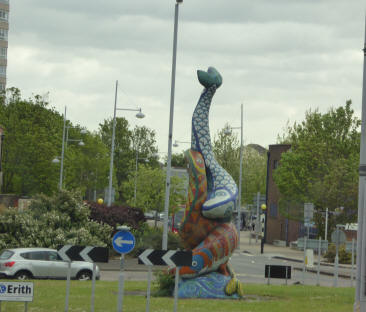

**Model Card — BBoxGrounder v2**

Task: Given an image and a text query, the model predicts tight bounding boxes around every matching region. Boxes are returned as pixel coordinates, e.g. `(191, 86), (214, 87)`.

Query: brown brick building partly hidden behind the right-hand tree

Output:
(265, 144), (300, 245)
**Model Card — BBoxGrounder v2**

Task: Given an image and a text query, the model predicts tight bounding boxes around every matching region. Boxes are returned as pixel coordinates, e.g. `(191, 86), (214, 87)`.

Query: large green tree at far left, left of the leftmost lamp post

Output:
(0, 88), (63, 196)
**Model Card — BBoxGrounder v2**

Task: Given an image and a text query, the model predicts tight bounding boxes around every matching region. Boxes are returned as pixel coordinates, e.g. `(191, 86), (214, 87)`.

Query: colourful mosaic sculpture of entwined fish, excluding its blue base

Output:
(177, 67), (243, 297)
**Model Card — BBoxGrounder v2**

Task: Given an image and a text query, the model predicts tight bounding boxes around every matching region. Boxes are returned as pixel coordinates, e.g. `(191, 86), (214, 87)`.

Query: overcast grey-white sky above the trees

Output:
(7, 0), (366, 152)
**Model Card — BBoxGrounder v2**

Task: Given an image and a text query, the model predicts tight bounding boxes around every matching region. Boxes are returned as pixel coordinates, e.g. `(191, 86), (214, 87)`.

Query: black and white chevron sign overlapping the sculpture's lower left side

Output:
(138, 249), (192, 267)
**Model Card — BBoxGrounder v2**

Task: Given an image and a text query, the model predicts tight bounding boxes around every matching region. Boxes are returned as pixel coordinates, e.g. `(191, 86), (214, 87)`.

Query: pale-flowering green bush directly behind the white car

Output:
(0, 191), (112, 250)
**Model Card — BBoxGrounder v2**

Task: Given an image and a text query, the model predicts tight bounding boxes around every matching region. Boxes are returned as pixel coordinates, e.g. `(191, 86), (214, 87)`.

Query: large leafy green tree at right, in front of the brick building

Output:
(274, 101), (360, 234)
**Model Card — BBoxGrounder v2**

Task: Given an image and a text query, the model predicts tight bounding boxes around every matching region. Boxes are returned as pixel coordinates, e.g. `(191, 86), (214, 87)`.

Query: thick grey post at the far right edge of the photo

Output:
(354, 20), (366, 312)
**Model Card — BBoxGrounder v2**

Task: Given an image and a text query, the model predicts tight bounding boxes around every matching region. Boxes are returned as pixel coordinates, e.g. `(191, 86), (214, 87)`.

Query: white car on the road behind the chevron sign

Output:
(0, 248), (100, 280)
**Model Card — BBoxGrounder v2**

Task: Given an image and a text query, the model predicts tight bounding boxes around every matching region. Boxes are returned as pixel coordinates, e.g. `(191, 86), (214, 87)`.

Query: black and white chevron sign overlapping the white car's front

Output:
(57, 245), (109, 262)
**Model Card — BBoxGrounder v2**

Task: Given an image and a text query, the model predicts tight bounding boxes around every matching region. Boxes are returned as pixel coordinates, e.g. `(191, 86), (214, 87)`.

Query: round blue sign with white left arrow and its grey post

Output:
(112, 226), (135, 312)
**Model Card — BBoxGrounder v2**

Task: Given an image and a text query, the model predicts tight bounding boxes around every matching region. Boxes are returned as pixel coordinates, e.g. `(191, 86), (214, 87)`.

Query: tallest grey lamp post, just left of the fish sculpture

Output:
(162, 0), (183, 250)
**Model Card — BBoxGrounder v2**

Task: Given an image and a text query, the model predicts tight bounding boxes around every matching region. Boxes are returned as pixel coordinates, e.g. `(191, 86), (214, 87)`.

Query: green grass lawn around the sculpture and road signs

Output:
(1, 280), (355, 312)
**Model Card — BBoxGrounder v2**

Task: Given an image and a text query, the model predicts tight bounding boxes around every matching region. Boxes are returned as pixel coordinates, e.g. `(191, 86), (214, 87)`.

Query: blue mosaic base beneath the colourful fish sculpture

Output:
(178, 272), (239, 299)
